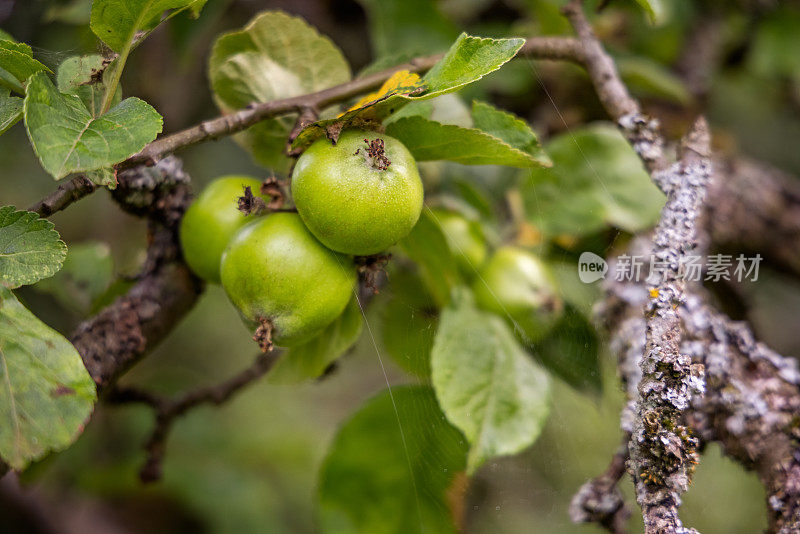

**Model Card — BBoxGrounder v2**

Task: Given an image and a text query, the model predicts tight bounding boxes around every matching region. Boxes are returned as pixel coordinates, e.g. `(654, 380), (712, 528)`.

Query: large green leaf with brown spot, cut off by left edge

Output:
(0, 287), (95, 470)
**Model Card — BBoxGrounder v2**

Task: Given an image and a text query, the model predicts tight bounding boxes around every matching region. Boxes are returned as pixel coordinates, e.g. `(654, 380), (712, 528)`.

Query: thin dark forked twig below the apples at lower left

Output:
(106, 352), (279, 483)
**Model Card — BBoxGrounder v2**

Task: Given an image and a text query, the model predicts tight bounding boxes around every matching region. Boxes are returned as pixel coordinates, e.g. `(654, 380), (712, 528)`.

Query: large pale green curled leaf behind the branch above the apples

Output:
(209, 11), (350, 170)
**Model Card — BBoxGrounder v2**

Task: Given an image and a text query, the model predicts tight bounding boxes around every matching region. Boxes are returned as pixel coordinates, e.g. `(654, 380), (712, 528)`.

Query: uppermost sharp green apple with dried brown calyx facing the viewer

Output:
(292, 130), (423, 256)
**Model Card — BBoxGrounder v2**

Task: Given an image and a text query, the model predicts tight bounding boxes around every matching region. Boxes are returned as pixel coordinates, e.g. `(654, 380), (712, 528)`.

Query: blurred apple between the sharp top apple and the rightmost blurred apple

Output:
(431, 208), (486, 278)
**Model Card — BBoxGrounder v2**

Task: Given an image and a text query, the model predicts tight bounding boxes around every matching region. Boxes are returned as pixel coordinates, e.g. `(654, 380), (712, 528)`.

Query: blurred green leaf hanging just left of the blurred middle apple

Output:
(398, 209), (460, 306)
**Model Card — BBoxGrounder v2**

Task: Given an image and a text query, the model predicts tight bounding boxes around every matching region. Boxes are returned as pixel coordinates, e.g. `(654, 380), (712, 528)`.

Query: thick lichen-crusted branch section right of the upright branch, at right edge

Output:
(681, 296), (800, 534)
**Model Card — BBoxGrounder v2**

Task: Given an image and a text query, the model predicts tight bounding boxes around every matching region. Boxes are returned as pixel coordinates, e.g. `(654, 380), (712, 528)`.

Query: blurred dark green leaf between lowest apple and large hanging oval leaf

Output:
(380, 298), (438, 378)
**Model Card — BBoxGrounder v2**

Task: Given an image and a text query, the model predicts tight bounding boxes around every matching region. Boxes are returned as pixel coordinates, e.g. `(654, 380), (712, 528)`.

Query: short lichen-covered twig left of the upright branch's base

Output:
(569, 442), (631, 534)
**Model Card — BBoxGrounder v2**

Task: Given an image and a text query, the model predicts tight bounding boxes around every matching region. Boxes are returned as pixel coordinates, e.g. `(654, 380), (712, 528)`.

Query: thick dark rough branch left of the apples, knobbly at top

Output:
(71, 157), (203, 391)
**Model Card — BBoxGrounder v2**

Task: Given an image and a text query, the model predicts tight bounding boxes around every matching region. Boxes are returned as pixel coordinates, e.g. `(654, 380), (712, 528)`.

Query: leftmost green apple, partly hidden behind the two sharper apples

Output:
(180, 176), (269, 283)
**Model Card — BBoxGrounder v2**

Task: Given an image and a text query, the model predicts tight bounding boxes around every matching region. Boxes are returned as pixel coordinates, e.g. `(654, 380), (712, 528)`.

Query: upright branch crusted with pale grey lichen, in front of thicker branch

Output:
(629, 119), (711, 534)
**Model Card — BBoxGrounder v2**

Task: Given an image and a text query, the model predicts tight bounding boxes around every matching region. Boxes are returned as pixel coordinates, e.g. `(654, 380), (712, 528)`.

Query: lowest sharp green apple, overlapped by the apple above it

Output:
(220, 213), (356, 347)
